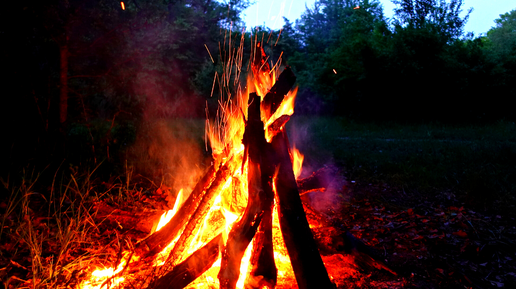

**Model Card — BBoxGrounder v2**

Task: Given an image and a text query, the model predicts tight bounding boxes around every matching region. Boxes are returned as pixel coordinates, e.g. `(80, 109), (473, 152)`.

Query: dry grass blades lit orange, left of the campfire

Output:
(0, 163), (156, 288)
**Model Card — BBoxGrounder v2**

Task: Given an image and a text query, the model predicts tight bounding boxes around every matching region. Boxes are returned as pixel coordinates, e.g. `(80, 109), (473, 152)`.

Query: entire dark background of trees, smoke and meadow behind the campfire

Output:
(0, 0), (516, 205)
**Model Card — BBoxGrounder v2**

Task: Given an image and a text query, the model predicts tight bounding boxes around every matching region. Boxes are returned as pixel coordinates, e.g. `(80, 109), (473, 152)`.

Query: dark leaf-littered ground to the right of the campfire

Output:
(312, 173), (516, 288)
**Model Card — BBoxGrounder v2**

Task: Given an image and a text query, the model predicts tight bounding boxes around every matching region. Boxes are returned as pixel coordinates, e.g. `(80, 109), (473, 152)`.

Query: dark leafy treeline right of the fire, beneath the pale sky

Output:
(289, 0), (516, 123)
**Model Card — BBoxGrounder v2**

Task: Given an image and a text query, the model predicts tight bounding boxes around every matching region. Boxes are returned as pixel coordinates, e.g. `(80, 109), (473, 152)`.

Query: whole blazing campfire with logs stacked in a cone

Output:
(79, 37), (384, 289)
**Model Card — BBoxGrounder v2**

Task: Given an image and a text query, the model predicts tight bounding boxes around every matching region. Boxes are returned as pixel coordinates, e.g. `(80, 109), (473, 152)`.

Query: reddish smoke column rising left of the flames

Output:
(120, 21), (211, 194)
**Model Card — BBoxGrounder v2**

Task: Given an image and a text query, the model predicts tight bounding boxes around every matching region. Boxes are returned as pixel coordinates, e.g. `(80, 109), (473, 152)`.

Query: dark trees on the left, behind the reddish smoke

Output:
(0, 0), (248, 172)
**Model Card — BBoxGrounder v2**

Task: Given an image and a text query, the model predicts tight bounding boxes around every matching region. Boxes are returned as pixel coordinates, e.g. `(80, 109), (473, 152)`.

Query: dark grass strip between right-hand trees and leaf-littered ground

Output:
(289, 116), (516, 207)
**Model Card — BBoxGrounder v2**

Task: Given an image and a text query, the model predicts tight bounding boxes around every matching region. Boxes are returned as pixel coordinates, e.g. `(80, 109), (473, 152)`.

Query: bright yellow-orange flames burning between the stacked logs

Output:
(79, 36), (303, 289)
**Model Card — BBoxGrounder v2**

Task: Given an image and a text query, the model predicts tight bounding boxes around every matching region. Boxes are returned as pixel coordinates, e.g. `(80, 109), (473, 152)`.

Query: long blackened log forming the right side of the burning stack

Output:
(272, 132), (334, 289)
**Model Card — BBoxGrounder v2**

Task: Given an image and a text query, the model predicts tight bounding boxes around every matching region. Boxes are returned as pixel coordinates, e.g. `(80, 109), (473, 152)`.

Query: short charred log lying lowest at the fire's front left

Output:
(149, 234), (222, 289)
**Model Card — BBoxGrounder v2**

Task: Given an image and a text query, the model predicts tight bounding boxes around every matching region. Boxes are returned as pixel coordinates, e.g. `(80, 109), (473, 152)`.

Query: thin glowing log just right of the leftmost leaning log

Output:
(168, 156), (238, 264)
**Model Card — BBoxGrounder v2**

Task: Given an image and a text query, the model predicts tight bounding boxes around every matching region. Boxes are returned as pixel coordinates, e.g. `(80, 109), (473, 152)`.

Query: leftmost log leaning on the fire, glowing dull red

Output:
(135, 165), (217, 257)
